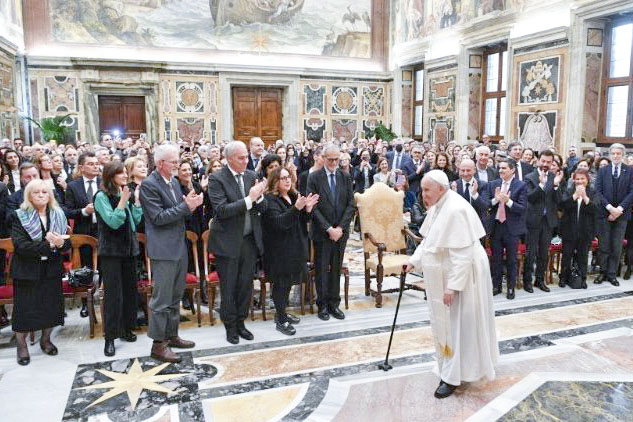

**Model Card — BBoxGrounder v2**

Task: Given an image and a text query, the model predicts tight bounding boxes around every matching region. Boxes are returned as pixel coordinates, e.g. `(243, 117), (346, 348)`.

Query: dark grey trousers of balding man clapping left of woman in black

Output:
(215, 235), (257, 330)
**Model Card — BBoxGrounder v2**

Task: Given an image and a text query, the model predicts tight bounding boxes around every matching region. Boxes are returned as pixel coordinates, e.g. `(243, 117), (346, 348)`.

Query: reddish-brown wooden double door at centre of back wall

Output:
(232, 86), (283, 146)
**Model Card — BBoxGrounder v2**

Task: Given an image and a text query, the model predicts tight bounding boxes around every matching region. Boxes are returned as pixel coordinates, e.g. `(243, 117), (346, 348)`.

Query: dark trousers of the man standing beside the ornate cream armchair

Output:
(314, 238), (347, 309)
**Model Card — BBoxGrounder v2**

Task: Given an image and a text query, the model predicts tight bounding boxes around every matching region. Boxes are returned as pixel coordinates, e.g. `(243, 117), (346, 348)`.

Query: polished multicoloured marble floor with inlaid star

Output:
(0, 242), (633, 422)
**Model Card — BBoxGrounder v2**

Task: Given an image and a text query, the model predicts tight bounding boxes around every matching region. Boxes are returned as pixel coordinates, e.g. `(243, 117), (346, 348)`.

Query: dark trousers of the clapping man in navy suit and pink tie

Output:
(490, 221), (519, 289)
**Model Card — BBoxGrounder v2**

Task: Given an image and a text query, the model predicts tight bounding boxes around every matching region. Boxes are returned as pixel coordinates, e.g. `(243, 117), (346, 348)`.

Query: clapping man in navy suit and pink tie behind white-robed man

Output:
(488, 159), (527, 300)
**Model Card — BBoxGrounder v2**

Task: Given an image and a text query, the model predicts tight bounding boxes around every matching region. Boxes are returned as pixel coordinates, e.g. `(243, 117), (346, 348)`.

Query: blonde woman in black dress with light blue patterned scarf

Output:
(11, 179), (70, 365)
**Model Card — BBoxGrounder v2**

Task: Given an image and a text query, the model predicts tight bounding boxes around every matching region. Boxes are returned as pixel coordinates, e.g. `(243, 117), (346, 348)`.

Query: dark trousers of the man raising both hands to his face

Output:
(523, 217), (552, 285)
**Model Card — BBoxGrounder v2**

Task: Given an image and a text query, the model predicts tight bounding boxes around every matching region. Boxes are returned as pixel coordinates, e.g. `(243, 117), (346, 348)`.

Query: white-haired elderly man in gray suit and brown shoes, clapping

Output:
(140, 144), (202, 363)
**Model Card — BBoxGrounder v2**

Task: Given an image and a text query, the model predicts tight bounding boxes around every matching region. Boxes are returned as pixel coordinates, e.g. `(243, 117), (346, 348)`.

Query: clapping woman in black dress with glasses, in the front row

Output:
(262, 168), (319, 336)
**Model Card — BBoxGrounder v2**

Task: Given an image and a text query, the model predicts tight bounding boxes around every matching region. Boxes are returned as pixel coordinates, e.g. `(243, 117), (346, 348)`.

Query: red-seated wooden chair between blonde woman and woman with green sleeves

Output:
(62, 234), (99, 338)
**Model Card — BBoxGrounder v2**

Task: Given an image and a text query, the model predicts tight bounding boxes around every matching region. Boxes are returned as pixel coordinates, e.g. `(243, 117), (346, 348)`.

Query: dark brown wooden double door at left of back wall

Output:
(99, 95), (147, 139)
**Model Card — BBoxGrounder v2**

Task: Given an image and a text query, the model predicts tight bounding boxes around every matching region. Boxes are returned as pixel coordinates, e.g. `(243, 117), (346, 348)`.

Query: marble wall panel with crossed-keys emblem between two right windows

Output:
(506, 46), (569, 151)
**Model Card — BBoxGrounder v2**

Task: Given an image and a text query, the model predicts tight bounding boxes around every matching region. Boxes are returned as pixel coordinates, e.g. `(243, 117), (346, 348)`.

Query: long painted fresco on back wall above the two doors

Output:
(50, 0), (372, 58)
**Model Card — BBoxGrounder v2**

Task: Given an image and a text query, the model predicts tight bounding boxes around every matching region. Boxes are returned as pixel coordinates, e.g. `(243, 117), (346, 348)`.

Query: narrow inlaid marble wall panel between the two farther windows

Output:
(424, 65), (457, 144)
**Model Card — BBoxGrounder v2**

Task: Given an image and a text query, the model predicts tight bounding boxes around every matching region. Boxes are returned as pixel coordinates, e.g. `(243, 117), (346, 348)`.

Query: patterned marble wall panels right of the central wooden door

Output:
(298, 79), (390, 141)
